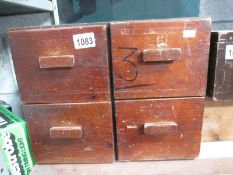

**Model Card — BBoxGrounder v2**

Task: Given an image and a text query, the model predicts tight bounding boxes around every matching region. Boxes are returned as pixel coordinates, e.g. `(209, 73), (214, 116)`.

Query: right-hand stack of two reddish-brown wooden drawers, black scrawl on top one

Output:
(110, 19), (210, 160)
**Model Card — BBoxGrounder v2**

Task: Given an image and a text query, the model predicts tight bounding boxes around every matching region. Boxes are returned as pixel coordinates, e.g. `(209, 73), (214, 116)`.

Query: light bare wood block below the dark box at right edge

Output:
(202, 98), (233, 141)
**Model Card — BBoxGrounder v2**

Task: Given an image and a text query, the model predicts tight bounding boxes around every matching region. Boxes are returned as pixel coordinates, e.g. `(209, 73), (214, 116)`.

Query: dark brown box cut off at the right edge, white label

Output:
(207, 31), (233, 100)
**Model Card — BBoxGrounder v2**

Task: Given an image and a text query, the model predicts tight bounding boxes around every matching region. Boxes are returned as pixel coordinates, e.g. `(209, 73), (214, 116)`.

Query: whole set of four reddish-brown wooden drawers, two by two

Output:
(9, 19), (210, 163)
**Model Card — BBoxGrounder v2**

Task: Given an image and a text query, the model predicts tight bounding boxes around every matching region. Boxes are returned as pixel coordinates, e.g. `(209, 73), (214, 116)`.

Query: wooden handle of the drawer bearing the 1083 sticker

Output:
(39, 55), (75, 69)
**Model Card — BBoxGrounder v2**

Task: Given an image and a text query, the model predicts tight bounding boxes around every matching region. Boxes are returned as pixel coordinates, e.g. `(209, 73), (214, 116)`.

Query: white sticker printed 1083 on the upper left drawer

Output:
(73, 32), (96, 49)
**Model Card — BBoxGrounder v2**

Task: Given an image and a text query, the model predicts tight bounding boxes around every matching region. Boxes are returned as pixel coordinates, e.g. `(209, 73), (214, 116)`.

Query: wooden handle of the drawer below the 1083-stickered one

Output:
(50, 126), (82, 139)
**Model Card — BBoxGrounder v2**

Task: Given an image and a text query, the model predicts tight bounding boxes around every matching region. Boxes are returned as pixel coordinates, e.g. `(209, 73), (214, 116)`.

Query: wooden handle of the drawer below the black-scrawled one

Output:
(144, 122), (177, 136)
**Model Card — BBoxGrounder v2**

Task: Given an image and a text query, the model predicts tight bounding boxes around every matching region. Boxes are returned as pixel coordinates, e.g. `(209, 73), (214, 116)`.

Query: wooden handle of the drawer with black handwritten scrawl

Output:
(142, 48), (181, 62)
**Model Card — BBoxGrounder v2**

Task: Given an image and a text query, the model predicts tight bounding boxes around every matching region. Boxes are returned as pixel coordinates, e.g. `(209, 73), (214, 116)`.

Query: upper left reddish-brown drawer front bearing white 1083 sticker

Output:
(8, 25), (110, 103)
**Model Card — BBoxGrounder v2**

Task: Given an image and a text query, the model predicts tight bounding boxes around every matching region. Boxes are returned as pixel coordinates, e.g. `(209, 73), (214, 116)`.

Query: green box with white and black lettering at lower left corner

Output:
(0, 106), (34, 175)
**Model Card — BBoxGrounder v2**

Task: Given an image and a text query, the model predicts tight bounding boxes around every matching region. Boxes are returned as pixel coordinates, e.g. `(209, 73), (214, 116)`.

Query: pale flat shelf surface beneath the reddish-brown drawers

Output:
(31, 141), (233, 175)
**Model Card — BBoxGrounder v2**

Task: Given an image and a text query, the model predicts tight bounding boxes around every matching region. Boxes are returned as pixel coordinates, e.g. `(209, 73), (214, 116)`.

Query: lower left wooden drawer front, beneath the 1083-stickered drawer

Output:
(24, 102), (114, 163)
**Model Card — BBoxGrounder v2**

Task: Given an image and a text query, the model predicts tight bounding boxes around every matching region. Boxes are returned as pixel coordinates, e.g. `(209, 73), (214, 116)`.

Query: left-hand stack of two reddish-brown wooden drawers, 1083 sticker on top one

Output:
(8, 25), (114, 163)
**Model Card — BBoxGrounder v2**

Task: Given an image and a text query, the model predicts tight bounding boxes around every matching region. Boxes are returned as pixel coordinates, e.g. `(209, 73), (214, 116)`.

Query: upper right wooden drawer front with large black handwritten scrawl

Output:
(111, 19), (210, 99)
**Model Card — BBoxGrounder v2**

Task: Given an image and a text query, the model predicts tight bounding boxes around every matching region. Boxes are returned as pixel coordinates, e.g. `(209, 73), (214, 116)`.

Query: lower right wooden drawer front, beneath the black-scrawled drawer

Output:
(116, 98), (204, 160)
